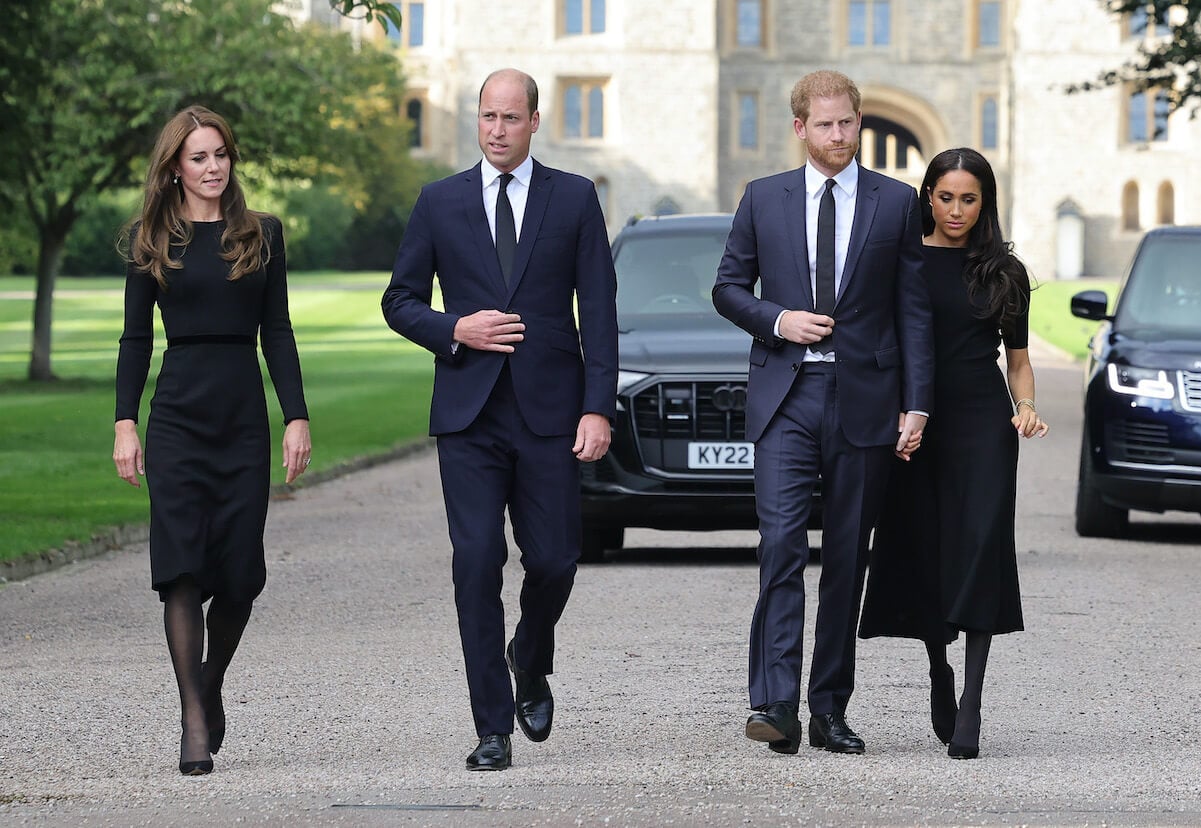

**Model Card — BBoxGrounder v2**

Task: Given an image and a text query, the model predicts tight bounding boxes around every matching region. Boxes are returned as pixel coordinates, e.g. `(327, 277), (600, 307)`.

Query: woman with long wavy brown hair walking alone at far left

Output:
(113, 106), (311, 775)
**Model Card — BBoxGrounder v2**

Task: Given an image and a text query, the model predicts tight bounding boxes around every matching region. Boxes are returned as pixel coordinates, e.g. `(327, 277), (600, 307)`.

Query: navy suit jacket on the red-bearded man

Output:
(713, 167), (934, 446)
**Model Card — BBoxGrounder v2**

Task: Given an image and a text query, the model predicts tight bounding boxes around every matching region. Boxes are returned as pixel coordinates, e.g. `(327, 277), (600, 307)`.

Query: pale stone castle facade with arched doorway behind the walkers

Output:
(285, 0), (1201, 280)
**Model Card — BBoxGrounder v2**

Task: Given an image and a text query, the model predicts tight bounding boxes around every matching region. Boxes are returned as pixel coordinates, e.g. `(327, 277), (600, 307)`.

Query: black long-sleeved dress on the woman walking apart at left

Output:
(116, 216), (309, 601)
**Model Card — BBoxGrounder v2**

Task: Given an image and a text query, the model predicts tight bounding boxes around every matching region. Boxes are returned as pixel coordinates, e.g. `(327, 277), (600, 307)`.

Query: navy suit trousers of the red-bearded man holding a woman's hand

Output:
(749, 363), (892, 714)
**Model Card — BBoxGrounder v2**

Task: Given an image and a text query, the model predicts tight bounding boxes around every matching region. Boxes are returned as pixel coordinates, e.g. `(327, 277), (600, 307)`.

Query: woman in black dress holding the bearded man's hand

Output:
(859, 148), (1048, 760)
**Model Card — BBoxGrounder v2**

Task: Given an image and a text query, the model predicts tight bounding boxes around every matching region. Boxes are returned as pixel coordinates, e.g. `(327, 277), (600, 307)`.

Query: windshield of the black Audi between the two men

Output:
(614, 227), (730, 328)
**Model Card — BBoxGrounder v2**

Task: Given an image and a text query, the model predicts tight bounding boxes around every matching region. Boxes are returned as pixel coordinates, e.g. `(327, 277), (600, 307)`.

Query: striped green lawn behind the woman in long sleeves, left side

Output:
(0, 273), (434, 560)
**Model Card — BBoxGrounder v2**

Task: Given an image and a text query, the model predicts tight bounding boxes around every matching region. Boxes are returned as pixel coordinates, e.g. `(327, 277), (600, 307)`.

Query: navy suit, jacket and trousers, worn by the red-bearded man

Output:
(713, 161), (933, 715)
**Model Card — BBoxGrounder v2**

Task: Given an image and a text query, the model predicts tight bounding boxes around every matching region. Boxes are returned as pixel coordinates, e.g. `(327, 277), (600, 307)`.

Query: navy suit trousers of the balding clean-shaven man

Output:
(437, 364), (580, 737)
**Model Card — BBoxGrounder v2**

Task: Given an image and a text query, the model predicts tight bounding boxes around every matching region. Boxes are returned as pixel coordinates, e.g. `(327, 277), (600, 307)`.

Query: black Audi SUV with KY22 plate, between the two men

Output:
(581, 214), (758, 561)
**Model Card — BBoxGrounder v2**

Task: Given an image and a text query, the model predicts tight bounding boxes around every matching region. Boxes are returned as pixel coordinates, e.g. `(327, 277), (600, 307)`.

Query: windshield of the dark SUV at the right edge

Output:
(1115, 234), (1201, 336)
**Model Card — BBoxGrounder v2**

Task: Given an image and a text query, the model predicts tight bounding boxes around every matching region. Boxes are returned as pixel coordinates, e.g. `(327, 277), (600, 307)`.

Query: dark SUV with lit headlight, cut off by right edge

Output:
(1071, 227), (1201, 537)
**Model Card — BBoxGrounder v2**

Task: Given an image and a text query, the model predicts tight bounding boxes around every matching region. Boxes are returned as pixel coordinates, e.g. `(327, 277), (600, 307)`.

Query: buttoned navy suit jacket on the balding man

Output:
(382, 161), (617, 436)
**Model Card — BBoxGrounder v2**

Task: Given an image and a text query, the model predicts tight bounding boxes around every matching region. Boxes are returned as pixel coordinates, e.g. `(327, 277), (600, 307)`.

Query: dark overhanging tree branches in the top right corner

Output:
(1068, 0), (1201, 117)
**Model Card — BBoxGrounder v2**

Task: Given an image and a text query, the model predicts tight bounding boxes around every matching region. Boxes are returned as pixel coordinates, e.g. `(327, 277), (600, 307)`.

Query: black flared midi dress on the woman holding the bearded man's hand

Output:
(859, 246), (1028, 643)
